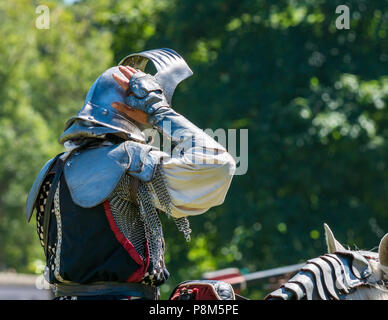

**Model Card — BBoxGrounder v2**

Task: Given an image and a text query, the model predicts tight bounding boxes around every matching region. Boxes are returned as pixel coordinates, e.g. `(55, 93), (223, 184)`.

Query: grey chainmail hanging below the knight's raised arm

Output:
(109, 165), (191, 284)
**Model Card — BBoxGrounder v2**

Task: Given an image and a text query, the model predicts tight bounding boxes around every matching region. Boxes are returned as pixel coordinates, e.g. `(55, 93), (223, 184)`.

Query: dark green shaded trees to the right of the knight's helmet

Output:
(141, 0), (388, 298)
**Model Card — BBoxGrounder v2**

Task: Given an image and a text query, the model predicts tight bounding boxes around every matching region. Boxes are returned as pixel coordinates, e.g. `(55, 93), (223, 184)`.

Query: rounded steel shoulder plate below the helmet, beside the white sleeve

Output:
(64, 141), (158, 208)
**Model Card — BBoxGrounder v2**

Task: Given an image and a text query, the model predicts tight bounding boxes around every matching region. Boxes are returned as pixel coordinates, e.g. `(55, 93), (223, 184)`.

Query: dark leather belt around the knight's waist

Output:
(54, 282), (159, 300)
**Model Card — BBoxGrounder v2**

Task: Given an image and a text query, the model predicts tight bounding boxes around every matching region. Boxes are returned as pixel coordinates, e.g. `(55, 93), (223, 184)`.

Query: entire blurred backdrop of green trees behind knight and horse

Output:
(0, 0), (388, 298)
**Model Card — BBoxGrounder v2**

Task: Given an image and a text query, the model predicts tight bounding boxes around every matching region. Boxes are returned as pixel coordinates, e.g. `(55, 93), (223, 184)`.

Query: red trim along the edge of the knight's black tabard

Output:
(104, 200), (150, 282)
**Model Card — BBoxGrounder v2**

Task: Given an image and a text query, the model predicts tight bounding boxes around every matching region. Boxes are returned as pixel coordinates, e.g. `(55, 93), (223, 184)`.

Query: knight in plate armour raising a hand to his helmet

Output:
(26, 49), (236, 299)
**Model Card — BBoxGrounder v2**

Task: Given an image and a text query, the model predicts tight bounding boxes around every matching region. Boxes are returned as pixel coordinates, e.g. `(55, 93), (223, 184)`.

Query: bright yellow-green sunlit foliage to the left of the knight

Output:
(0, 0), (112, 271)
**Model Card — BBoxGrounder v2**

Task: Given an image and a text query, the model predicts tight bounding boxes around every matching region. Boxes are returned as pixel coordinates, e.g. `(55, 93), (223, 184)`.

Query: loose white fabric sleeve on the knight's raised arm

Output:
(151, 131), (236, 218)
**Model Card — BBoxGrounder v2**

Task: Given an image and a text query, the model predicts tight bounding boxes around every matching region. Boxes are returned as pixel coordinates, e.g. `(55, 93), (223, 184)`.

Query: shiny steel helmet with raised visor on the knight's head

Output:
(59, 48), (193, 143)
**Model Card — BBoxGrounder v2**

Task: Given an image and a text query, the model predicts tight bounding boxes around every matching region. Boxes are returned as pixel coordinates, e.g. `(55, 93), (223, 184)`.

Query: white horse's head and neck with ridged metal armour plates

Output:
(265, 224), (388, 300)
